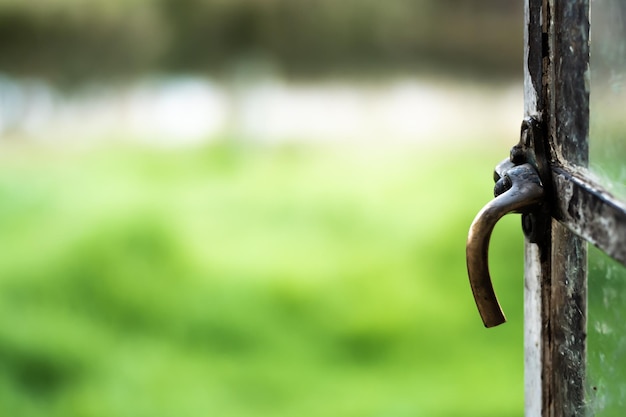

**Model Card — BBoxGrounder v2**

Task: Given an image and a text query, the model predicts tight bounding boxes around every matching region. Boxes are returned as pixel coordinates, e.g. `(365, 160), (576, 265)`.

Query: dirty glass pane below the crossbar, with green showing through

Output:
(586, 245), (626, 417)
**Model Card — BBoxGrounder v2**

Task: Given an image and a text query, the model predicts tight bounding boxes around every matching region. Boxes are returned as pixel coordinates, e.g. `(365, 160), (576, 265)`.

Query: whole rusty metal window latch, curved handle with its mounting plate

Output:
(466, 119), (545, 327)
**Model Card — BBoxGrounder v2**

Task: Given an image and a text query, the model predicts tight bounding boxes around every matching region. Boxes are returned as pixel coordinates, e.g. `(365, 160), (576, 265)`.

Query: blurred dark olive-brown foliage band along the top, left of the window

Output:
(0, 0), (523, 83)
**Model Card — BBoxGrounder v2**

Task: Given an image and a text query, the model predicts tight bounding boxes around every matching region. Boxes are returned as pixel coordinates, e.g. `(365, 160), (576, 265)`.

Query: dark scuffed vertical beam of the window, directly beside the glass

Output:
(540, 0), (589, 417)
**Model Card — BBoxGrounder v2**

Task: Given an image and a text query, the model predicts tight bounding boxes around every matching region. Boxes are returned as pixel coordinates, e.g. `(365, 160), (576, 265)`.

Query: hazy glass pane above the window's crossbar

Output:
(589, 0), (626, 197)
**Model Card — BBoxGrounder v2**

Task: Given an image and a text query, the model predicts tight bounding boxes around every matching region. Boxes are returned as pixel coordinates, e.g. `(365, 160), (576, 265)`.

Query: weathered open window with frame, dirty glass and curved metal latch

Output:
(468, 0), (626, 417)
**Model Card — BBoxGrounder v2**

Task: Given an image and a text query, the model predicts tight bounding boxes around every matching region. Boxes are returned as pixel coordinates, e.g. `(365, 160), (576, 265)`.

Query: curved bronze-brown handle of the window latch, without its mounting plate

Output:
(466, 159), (544, 327)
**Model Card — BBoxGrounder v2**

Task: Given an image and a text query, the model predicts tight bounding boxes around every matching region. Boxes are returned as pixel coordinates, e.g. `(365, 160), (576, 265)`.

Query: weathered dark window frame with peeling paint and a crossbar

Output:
(524, 0), (626, 417)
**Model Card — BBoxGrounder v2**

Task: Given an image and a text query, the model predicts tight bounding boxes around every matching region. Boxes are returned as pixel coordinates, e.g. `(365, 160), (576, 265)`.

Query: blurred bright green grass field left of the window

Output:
(0, 141), (523, 417)
